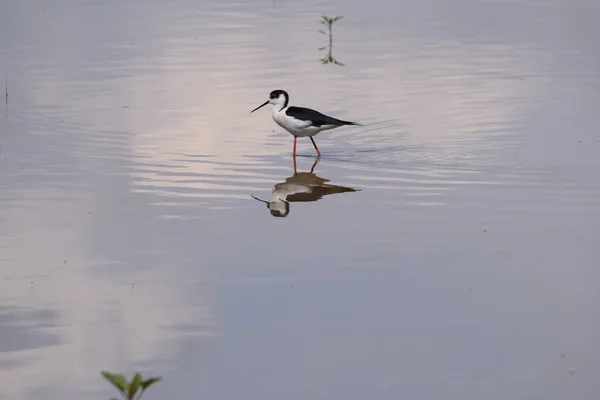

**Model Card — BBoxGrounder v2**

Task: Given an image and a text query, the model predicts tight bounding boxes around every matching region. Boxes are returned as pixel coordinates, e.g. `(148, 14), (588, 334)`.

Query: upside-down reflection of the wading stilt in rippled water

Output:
(251, 157), (359, 217)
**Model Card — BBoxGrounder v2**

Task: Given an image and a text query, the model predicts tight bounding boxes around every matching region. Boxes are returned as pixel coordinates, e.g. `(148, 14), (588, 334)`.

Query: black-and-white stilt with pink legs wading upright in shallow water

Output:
(250, 90), (362, 156)
